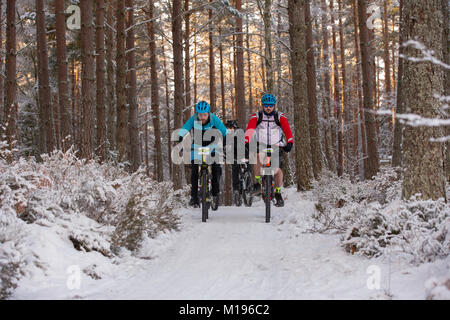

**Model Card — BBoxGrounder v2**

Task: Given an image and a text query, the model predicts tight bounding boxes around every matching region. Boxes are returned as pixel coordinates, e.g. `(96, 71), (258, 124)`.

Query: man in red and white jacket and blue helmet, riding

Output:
(245, 94), (294, 207)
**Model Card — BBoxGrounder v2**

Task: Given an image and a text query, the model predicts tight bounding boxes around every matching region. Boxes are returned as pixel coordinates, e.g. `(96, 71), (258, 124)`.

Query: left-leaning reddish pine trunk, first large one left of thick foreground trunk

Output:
(358, 0), (379, 179)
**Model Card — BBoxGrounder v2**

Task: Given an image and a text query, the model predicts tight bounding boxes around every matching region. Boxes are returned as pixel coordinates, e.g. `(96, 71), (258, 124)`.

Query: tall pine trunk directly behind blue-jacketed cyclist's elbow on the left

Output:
(172, 0), (185, 190)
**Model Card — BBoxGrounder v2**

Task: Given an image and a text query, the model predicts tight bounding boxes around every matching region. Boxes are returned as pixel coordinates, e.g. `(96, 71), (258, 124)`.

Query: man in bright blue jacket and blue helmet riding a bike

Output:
(179, 101), (228, 207)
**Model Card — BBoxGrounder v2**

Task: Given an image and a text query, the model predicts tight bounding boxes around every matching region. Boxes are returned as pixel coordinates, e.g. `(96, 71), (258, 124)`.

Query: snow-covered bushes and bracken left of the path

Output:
(0, 142), (186, 299)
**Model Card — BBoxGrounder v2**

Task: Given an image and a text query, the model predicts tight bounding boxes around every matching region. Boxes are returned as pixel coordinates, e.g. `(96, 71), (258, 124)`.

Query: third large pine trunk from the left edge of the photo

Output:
(55, 0), (73, 152)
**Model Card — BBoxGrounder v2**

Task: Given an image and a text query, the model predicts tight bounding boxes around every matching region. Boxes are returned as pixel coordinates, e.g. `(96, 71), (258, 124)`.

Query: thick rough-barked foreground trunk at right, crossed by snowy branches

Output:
(402, 0), (446, 199)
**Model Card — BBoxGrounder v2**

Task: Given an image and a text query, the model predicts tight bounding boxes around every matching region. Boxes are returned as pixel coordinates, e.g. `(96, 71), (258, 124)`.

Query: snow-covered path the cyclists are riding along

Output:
(11, 190), (450, 299)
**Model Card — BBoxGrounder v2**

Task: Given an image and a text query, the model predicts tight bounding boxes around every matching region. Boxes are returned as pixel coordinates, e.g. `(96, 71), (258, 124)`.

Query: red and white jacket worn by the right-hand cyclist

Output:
(245, 112), (294, 147)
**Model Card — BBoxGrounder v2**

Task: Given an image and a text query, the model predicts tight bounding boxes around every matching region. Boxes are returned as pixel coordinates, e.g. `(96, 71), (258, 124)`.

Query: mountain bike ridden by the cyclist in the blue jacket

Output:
(198, 147), (219, 222)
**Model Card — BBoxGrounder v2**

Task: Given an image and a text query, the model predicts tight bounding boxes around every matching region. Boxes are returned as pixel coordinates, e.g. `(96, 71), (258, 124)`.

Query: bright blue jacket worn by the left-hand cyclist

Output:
(178, 112), (228, 160)
